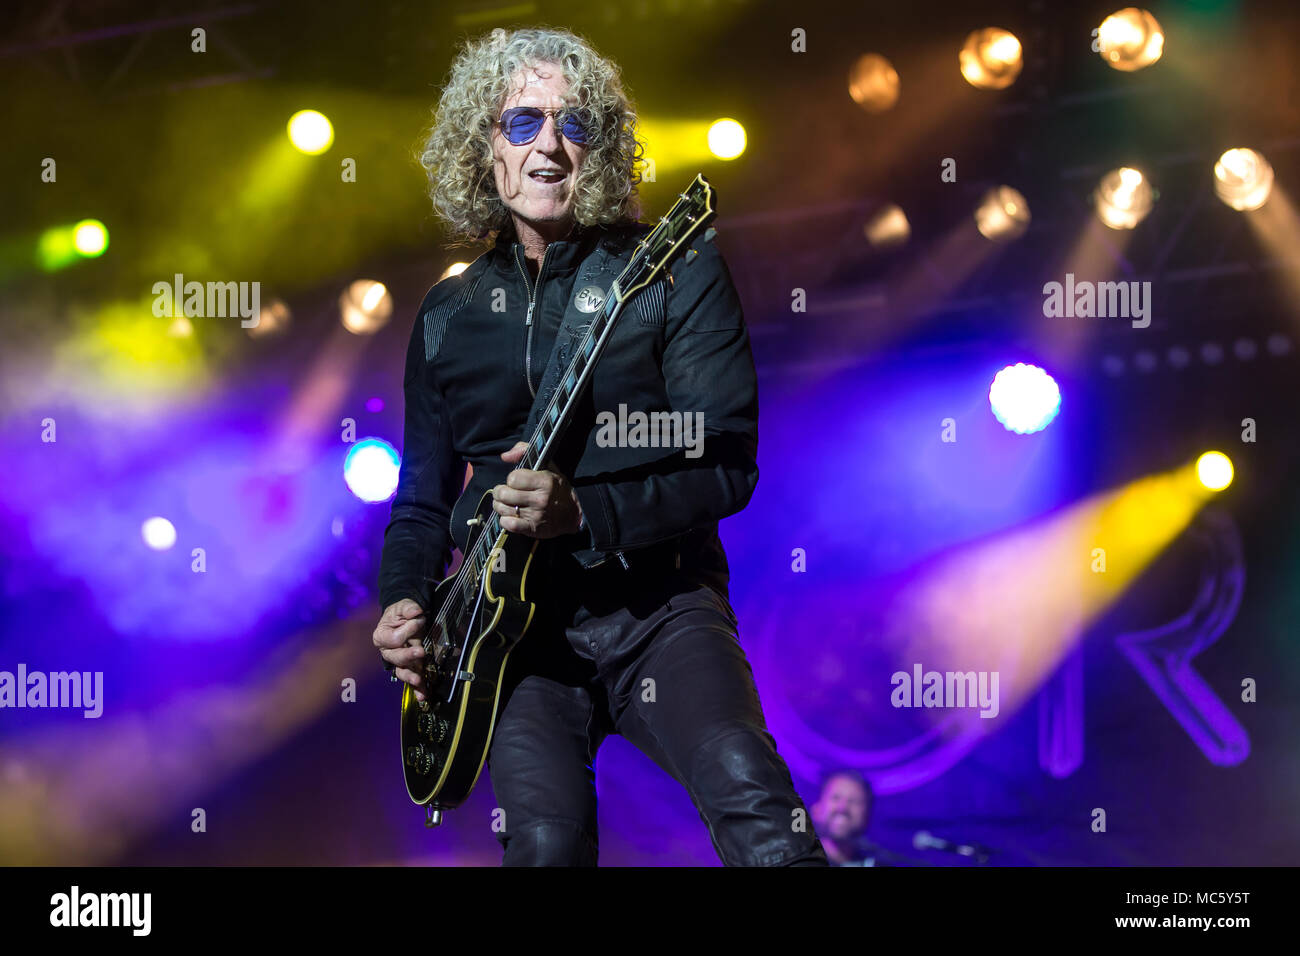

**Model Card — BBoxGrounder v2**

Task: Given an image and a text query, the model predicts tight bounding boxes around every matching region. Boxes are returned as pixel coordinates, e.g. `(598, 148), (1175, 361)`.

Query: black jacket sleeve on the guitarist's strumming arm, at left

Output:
(380, 299), (465, 607)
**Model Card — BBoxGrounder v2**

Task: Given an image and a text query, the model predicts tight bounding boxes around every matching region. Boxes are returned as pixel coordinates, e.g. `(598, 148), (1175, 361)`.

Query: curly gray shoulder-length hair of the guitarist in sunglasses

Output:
(420, 29), (645, 246)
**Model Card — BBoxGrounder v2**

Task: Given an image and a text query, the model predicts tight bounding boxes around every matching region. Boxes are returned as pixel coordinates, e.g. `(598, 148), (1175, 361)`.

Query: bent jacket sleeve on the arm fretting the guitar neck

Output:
(573, 241), (758, 551)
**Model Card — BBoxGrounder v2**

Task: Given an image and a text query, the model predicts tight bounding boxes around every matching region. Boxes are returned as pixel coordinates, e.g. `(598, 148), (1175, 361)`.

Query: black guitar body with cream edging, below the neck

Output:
(402, 492), (538, 810)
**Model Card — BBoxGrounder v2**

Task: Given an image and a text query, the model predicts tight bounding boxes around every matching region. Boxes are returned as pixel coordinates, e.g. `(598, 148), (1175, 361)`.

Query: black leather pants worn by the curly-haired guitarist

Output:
(489, 562), (827, 866)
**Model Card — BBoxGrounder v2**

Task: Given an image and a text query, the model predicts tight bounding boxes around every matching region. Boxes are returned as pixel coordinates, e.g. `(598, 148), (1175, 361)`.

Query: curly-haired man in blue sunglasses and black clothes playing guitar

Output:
(374, 30), (827, 866)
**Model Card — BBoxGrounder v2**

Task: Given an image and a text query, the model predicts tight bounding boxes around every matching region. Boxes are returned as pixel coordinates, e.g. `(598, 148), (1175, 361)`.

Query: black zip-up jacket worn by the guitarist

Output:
(380, 217), (758, 607)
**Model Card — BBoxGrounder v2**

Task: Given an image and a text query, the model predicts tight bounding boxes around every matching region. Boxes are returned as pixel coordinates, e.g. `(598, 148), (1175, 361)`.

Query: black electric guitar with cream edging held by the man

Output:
(402, 176), (716, 827)
